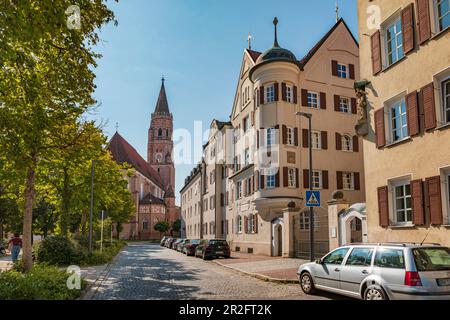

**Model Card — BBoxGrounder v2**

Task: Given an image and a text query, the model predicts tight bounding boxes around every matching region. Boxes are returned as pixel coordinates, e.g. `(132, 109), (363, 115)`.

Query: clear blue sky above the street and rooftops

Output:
(93, 0), (357, 202)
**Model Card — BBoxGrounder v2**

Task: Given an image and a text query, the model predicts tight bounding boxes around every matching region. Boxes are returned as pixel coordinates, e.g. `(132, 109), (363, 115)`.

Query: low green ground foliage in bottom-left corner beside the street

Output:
(0, 264), (86, 300)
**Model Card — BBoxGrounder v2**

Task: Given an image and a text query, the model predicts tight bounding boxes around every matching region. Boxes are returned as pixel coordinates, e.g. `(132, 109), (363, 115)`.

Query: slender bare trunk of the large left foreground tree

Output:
(22, 154), (36, 271)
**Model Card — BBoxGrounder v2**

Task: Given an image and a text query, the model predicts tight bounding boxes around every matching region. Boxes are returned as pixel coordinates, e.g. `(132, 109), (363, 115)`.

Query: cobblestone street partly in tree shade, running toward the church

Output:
(86, 243), (342, 300)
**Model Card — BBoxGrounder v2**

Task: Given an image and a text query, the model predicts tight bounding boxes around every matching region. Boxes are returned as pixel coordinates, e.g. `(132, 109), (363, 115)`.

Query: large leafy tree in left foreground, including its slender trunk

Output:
(0, 0), (118, 271)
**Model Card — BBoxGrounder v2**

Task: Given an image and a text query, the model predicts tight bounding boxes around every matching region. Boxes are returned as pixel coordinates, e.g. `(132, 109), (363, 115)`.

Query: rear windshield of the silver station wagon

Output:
(412, 248), (450, 271)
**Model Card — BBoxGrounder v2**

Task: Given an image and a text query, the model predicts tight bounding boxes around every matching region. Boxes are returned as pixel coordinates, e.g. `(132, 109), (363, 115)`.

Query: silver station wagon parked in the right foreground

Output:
(297, 243), (450, 300)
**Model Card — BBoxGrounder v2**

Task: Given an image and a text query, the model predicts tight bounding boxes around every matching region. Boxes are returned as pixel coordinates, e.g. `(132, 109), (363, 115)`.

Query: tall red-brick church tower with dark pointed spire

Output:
(147, 78), (175, 192)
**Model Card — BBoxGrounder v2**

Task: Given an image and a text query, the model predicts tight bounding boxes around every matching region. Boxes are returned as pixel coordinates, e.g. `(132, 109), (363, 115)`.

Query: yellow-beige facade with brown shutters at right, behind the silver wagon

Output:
(357, 0), (450, 246)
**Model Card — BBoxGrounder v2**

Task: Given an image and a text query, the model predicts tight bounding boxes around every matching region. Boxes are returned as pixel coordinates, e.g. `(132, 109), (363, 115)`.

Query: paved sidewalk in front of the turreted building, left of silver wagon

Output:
(213, 252), (307, 283)
